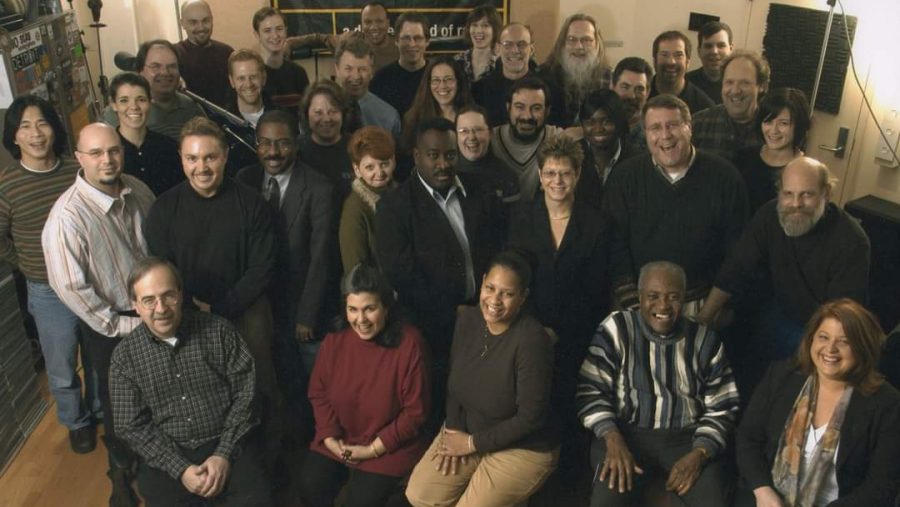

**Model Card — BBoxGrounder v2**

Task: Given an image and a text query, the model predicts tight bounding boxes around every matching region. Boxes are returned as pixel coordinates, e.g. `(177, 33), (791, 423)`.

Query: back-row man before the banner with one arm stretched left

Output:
(287, 2), (400, 71)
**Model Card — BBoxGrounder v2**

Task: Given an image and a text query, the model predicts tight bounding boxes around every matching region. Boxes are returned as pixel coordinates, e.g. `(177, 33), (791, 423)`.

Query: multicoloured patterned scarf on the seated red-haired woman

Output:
(772, 375), (853, 507)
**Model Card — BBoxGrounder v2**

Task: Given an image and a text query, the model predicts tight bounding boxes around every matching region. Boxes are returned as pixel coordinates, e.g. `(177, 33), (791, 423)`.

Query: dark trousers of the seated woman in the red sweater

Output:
(300, 451), (401, 507)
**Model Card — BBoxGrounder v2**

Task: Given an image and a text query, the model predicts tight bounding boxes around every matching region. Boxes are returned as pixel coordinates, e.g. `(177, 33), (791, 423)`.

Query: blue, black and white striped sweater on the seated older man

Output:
(576, 310), (739, 455)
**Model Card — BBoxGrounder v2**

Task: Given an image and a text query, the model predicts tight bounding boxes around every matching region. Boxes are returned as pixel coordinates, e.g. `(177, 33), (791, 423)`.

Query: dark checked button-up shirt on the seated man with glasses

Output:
(109, 311), (256, 479)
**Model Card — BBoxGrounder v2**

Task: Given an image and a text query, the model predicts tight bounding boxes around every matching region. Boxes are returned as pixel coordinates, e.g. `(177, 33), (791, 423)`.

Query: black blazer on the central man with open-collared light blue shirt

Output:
(375, 171), (505, 359)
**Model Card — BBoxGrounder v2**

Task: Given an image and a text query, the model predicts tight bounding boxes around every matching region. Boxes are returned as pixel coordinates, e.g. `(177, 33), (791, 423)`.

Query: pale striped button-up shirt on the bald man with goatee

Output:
(41, 172), (154, 337)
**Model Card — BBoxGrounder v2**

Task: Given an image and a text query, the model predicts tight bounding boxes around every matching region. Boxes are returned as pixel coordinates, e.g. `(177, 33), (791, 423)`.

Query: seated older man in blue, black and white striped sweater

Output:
(576, 261), (739, 507)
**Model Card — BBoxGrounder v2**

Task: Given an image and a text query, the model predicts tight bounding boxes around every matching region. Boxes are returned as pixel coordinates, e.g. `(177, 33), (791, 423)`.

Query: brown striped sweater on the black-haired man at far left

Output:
(0, 158), (79, 283)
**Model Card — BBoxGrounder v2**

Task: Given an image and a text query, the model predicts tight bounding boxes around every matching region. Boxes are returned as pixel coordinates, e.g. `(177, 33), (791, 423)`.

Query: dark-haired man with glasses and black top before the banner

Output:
(371, 11), (430, 118)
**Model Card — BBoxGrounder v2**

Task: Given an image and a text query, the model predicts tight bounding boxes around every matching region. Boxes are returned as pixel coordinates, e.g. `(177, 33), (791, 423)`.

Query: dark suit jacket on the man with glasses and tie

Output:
(237, 161), (337, 330)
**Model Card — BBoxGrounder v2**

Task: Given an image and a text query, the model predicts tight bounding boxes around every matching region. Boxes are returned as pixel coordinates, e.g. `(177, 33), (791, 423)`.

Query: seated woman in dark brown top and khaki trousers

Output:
(406, 252), (559, 507)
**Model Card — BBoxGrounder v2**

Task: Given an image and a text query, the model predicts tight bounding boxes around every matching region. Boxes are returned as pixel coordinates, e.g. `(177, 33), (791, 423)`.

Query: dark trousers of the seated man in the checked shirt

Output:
(137, 438), (272, 507)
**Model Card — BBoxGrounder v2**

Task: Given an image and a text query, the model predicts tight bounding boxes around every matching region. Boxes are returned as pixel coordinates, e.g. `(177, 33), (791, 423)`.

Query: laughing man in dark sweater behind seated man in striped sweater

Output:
(603, 95), (748, 316)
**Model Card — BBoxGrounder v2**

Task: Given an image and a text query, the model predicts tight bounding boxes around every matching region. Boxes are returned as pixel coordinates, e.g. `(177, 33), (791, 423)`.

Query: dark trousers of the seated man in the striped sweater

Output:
(591, 428), (730, 507)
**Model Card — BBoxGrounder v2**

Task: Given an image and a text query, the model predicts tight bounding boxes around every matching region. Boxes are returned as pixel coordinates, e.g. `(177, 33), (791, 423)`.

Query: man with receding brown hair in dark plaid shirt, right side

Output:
(694, 50), (770, 160)
